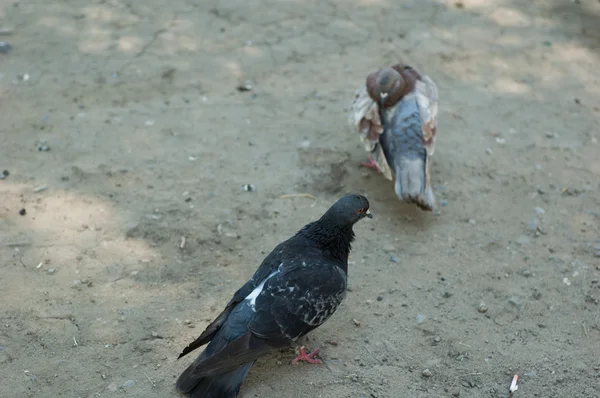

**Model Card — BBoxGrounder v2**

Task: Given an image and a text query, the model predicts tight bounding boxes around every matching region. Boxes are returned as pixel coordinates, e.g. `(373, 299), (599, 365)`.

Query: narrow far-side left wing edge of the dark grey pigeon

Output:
(177, 238), (288, 359)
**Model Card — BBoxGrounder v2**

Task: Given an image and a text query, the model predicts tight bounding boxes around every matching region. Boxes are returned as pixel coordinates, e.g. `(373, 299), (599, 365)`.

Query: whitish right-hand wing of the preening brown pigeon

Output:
(415, 75), (438, 156)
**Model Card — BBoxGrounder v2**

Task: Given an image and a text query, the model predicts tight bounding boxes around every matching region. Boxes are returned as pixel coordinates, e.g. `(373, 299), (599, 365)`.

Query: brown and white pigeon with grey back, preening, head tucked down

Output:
(348, 64), (438, 211)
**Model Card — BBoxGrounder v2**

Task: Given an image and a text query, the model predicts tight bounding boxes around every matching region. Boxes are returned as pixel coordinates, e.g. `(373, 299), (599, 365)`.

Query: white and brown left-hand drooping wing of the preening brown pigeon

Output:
(348, 84), (392, 180)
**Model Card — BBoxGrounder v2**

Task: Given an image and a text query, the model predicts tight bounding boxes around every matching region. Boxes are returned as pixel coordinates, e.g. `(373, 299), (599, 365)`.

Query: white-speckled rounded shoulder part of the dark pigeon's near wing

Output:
(249, 252), (346, 346)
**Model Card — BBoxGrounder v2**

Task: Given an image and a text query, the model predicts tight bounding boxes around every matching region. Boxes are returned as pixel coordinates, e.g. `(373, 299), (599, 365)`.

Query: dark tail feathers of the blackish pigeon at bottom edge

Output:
(190, 361), (254, 398)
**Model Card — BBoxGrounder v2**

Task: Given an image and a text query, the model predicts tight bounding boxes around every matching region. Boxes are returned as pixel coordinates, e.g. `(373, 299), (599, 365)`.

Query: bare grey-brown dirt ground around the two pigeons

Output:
(0, 0), (600, 398)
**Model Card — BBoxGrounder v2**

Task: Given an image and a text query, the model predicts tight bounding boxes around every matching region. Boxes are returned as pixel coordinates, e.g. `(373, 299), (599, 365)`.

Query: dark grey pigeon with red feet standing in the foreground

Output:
(177, 195), (373, 398)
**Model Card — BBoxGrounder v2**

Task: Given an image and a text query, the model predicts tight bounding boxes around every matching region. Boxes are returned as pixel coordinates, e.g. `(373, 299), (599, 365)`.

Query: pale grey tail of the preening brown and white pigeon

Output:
(394, 156), (435, 211)
